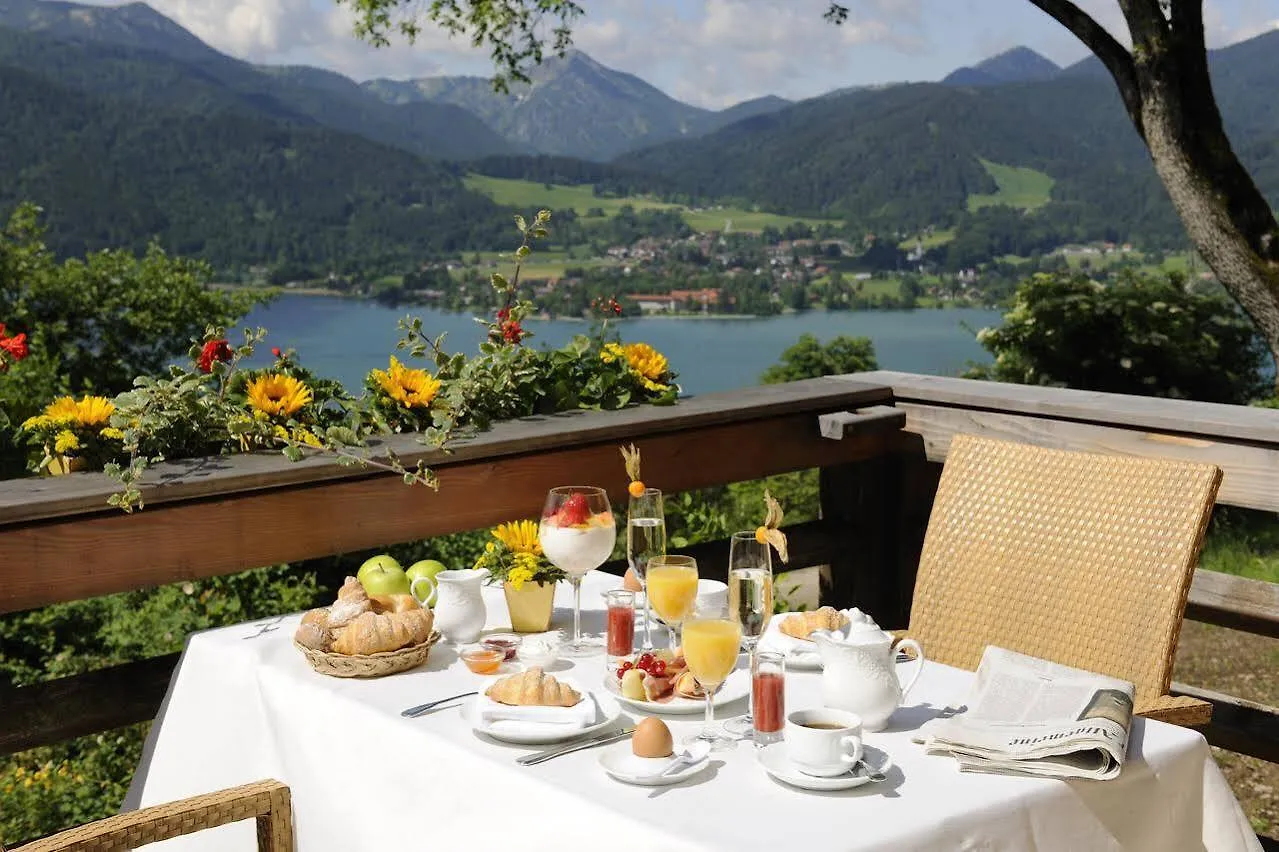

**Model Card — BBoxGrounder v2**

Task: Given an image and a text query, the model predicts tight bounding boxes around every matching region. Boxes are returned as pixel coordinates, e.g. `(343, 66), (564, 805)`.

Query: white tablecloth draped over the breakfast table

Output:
(134, 574), (1260, 852)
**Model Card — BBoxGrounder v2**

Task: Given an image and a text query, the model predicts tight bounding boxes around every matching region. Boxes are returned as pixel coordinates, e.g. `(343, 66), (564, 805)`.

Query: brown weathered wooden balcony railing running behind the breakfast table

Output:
(0, 372), (1279, 777)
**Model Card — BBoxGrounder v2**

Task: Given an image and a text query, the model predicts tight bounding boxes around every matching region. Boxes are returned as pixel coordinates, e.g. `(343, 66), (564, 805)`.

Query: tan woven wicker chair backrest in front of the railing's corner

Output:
(909, 435), (1221, 709)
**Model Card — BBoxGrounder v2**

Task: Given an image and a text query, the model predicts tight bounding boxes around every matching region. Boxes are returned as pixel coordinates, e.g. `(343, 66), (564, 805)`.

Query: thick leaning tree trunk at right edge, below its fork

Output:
(1137, 68), (1279, 381)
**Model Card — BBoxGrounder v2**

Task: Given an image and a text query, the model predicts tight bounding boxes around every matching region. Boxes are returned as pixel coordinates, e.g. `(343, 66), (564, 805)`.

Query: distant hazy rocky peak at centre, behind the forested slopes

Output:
(365, 51), (788, 160)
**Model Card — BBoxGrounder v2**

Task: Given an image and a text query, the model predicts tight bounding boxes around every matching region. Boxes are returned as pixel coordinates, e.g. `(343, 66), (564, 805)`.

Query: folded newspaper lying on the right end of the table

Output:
(921, 646), (1133, 780)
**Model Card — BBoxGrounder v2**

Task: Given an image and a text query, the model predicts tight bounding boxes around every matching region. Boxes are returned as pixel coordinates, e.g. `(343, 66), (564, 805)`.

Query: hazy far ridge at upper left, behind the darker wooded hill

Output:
(0, 0), (513, 159)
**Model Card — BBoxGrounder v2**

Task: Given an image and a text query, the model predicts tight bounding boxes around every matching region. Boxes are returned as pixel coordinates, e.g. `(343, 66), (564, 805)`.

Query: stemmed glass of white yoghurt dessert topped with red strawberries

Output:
(537, 485), (618, 656)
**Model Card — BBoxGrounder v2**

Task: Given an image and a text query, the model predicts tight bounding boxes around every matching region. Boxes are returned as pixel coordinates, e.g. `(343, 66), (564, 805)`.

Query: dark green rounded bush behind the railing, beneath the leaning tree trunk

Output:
(968, 270), (1266, 404)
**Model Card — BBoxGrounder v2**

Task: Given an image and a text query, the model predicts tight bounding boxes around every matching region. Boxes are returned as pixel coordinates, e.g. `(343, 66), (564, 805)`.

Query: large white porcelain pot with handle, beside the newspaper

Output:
(812, 610), (923, 730)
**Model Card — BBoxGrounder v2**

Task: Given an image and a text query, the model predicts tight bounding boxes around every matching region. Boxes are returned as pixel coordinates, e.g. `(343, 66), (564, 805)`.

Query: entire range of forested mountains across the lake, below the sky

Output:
(0, 0), (1279, 271)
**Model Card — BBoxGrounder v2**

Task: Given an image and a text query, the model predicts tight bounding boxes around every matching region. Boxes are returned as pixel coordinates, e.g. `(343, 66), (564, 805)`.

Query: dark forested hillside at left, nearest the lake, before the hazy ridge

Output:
(0, 65), (505, 271)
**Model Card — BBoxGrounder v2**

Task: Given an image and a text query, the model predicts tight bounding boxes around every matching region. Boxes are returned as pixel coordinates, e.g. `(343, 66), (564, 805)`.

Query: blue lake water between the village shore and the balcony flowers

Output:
(244, 296), (1000, 394)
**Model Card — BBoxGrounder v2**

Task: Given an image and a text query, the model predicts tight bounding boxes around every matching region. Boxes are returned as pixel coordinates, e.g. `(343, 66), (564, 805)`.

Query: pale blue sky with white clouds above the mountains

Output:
(79, 0), (1279, 107)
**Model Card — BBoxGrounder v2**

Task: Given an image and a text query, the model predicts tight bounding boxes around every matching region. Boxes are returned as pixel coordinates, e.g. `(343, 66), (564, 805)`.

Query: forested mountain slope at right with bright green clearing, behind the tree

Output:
(615, 32), (1279, 242)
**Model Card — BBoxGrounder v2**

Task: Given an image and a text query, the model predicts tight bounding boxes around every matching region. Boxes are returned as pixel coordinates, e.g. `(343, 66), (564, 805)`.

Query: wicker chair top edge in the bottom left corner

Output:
(0, 780), (293, 852)
